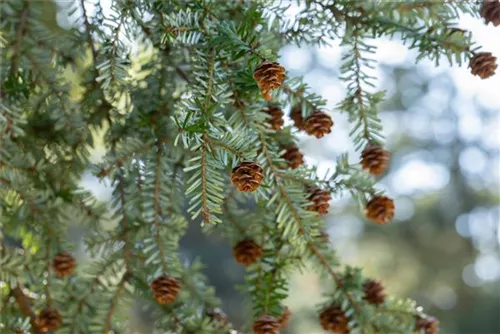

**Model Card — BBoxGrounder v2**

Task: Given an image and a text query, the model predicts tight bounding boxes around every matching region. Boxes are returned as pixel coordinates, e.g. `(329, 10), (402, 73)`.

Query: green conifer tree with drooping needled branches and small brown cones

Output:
(0, 0), (500, 334)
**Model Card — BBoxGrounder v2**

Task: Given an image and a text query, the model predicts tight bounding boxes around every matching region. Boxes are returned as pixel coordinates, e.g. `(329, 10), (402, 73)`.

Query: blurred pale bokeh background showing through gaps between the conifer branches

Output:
(6, 1), (500, 334)
